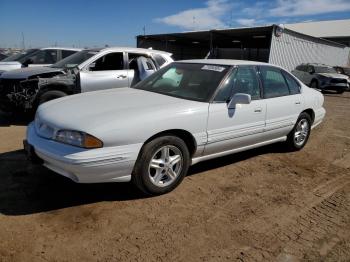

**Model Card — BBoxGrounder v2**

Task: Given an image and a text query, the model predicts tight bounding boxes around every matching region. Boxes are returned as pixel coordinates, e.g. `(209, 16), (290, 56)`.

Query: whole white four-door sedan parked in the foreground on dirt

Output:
(24, 60), (325, 195)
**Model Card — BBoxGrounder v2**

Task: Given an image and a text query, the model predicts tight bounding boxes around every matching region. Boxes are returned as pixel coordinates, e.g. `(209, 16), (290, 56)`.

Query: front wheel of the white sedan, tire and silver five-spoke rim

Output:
(132, 136), (190, 195)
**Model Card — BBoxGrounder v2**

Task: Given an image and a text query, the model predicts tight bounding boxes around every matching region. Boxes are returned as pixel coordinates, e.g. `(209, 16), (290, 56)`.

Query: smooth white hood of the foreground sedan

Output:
(37, 87), (208, 134)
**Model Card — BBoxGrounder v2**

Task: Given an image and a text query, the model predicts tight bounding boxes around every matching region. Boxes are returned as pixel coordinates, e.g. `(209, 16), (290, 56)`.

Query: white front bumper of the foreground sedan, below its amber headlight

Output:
(27, 122), (142, 183)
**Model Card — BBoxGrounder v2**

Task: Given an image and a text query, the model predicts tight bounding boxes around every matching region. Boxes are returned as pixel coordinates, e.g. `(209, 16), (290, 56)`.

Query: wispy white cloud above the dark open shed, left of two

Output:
(155, 0), (232, 30)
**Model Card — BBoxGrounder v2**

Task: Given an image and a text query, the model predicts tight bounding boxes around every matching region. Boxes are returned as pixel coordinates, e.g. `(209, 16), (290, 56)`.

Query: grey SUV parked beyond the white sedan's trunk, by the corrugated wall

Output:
(292, 64), (349, 94)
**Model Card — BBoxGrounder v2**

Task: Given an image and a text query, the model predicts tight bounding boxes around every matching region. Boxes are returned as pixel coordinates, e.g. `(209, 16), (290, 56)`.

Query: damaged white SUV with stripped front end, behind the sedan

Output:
(0, 47), (173, 112)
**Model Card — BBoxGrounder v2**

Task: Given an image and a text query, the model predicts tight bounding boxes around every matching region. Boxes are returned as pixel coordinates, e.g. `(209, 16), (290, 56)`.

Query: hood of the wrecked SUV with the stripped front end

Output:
(1, 66), (62, 79)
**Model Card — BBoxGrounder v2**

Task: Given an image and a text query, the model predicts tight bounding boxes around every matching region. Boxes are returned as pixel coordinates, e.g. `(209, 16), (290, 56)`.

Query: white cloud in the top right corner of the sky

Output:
(269, 0), (350, 17)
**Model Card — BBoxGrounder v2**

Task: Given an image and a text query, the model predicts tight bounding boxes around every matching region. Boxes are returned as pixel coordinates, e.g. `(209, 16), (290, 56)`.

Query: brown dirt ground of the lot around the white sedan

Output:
(0, 93), (350, 261)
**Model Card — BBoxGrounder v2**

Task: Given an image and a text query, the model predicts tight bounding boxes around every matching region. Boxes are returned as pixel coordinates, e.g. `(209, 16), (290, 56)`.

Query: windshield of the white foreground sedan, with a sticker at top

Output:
(134, 63), (229, 102)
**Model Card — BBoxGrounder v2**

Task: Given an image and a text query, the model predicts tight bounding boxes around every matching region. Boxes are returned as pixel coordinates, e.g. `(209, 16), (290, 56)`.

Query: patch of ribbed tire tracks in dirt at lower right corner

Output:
(232, 175), (350, 261)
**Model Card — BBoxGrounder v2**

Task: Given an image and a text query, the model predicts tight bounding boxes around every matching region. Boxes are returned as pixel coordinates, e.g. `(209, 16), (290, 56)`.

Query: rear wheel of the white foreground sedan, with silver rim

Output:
(287, 112), (312, 151)
